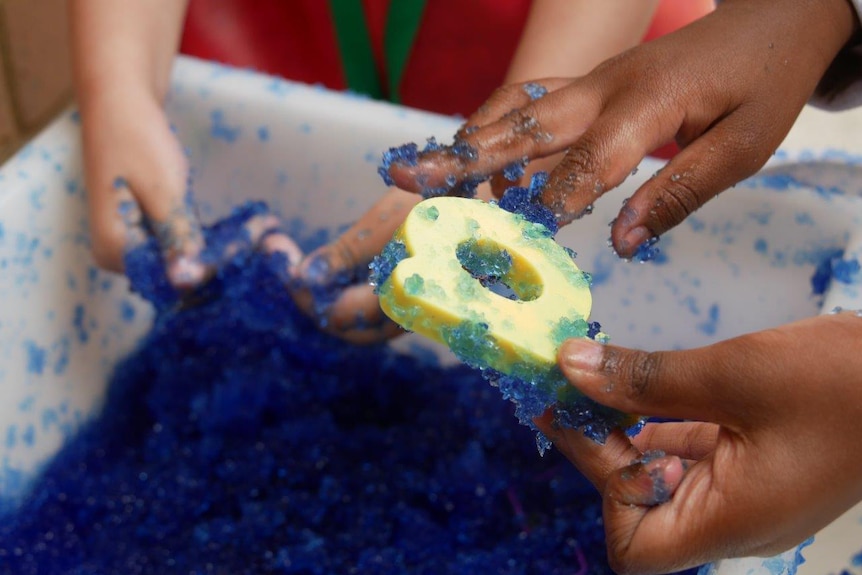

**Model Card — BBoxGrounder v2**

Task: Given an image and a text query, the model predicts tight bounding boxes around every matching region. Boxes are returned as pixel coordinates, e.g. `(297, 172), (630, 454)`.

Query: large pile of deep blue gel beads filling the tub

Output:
(0, 200), (700, 575)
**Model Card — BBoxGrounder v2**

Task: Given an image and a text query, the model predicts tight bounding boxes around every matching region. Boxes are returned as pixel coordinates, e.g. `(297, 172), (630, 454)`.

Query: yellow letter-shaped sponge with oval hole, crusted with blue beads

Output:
(375, 197), (636, 439)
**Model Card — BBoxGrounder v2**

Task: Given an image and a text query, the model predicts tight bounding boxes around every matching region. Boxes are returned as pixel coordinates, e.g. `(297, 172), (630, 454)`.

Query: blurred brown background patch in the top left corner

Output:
(0, 0), (72, 163)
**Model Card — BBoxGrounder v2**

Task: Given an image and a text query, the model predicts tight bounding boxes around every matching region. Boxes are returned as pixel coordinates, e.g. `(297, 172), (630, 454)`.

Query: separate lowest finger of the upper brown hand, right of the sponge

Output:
(608, 103), (780, 257)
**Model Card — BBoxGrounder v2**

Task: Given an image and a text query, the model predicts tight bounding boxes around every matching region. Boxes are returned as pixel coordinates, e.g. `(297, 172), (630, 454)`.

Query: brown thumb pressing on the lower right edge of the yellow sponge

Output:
(558, 339), (735, 423)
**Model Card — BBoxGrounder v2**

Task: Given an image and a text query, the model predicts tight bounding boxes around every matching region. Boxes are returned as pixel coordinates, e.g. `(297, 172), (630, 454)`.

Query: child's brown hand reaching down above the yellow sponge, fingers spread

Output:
(390, 0), (858, 257)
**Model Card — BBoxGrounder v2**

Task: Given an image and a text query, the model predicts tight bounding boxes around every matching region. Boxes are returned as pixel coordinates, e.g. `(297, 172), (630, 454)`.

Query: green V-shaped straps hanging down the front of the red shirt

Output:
(329, 0), (426, 103)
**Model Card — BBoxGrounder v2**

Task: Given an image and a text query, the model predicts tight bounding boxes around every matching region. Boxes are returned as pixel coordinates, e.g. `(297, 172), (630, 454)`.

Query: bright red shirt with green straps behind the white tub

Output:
(180, 0), (708, 117)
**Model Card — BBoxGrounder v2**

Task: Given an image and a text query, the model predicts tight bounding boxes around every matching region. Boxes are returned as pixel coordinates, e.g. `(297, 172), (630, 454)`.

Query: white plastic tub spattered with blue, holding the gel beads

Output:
(0, 59), (862, 575)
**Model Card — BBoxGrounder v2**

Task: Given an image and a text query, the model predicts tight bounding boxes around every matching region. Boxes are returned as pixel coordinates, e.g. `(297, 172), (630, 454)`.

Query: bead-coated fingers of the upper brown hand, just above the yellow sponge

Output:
(388, 80), (602, 198)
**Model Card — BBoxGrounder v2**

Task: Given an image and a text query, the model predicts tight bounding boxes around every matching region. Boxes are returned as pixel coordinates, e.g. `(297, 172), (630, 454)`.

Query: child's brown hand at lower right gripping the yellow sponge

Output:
(538, 312), (862, 574)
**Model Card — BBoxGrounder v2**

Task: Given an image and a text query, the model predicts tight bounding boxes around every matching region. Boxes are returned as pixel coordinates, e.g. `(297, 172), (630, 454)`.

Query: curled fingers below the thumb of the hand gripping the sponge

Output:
(536, 414), (751, 575)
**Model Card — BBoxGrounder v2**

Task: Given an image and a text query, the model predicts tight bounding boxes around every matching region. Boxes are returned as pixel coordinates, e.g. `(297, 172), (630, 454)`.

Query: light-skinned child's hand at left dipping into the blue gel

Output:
(81, 90), (212, 289)
